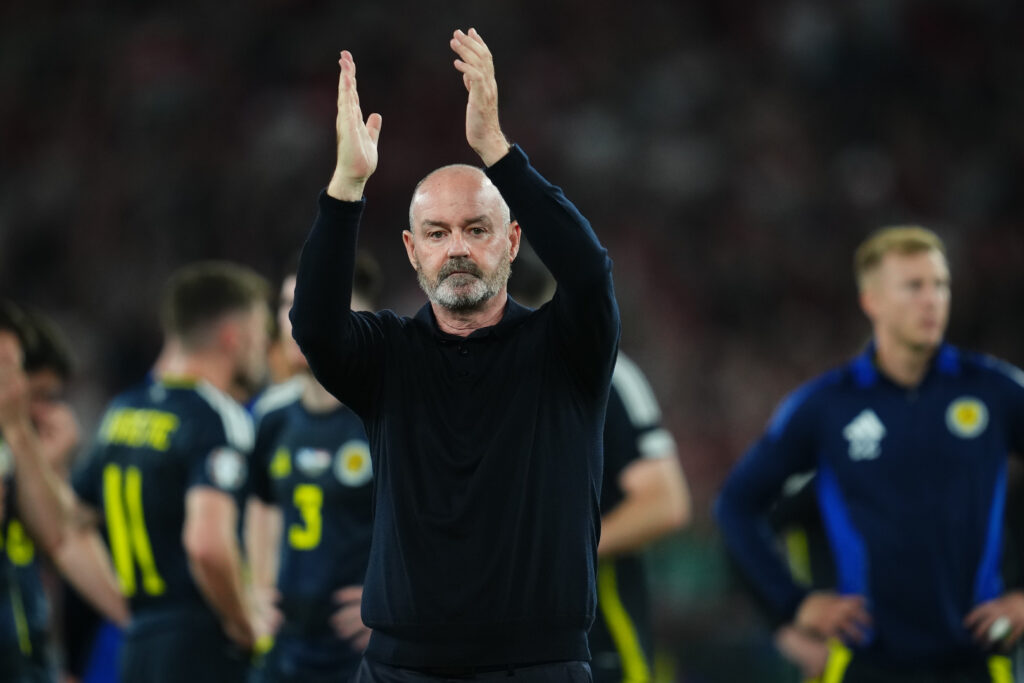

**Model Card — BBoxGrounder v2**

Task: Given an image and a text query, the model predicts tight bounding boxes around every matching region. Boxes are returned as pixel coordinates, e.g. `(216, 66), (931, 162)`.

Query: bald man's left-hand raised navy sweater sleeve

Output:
(289, 191), (384, 415)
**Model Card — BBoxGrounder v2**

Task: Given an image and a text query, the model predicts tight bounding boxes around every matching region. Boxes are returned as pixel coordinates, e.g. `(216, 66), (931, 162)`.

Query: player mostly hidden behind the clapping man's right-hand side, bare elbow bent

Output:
(509, 247), (690, 683)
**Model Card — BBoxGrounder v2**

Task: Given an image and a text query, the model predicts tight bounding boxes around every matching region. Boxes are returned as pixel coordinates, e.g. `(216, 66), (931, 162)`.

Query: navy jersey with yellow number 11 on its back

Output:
(73, 380), (254, 616)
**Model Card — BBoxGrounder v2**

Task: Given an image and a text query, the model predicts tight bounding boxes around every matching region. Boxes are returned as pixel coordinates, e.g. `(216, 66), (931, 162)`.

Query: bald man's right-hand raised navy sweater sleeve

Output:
(486, 145), (620, 395)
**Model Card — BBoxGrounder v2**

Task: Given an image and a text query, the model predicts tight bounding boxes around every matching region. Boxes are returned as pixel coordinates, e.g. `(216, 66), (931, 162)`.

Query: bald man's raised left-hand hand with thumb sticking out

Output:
(327, 50), (382, 202)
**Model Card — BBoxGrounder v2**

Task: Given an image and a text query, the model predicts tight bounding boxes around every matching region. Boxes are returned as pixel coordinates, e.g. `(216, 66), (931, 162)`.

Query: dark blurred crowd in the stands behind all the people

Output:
(0, 0), (1024, 682)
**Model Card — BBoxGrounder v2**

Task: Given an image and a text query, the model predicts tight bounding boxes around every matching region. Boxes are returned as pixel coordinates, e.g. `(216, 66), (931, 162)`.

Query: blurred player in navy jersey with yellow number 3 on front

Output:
(247, 257), (376, 683)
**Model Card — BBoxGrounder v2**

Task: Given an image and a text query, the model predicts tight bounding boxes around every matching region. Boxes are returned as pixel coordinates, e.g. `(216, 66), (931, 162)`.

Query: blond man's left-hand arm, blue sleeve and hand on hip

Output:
(715, 386), (870, 641)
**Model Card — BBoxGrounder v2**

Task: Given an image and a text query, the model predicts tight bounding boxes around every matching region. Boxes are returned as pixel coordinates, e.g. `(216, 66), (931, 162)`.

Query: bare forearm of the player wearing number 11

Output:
(182, 485), (256, 650)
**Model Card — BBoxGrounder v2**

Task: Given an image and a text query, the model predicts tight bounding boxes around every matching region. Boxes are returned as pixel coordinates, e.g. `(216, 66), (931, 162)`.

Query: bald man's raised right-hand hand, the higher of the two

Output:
(449, 29), (509, 166)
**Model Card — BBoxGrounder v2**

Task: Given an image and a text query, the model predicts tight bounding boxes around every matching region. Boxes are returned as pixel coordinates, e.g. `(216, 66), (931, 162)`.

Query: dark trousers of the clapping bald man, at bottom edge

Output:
(352, 657), (592, 683)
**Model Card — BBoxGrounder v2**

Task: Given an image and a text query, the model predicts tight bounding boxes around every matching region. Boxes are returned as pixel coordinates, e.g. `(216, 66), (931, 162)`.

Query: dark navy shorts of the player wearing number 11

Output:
(121, 609), (250, 683)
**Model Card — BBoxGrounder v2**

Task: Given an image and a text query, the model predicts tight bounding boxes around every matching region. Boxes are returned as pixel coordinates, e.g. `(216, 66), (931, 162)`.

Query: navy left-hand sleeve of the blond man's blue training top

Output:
(715, 387), (816, 621)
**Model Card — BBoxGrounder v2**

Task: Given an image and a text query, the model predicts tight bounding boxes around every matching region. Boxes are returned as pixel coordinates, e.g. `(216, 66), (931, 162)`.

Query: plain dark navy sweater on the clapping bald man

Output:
(291, 147), (620, 668)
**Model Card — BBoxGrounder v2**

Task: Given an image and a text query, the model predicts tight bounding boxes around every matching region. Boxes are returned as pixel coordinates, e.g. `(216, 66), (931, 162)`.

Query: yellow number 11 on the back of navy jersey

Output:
(103, 463), (167, 598)
